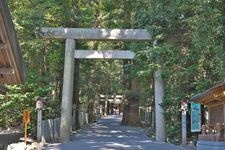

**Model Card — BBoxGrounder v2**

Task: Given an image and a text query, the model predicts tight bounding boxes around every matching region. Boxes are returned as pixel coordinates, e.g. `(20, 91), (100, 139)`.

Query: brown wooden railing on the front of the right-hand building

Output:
(199, 123), (225, 141)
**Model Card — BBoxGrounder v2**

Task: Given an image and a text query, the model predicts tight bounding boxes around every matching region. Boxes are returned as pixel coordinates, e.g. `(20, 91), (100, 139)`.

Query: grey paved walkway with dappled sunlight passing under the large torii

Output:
(43, 116), (188, 150)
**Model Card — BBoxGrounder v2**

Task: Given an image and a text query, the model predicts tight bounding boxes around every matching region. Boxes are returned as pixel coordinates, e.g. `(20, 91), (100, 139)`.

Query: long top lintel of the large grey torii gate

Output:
(36, 27), (151, 41)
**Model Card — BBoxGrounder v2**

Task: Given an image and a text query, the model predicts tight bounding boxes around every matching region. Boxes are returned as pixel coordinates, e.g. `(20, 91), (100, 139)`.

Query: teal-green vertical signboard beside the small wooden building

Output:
(191, 102), (201, 132)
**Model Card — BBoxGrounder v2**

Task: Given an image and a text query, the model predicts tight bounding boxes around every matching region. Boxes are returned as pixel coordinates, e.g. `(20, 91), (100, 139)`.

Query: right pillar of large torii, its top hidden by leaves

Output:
(154, 69), (166, 142)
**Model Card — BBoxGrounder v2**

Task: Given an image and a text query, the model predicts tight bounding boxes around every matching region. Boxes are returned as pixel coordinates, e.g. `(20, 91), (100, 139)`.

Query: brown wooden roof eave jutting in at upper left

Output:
(0, 0), (26, 91)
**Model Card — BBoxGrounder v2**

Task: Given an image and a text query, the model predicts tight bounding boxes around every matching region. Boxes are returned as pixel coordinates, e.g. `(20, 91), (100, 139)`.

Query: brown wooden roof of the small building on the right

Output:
(191, 82), (225, 105)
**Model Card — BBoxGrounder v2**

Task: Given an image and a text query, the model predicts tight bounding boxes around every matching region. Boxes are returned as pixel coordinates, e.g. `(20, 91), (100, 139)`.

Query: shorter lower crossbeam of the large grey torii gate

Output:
(74, 50), (135, 59)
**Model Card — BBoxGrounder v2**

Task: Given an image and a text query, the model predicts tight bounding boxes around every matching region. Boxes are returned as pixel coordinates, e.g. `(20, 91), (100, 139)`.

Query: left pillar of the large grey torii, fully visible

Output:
(60, 39), (75, 142)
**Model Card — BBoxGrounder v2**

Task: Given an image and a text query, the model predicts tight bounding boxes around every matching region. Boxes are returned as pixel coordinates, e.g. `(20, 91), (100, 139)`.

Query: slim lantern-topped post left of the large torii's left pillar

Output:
(36, 97), (43, 142)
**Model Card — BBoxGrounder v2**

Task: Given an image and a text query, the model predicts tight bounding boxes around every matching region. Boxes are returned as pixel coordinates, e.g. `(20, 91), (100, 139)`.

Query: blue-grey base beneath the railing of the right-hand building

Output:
(197, 141), (225, 150)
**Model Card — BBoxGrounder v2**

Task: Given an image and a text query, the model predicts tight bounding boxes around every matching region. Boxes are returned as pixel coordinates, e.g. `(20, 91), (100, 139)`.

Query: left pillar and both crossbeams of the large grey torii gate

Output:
(37, 27), (156, 142)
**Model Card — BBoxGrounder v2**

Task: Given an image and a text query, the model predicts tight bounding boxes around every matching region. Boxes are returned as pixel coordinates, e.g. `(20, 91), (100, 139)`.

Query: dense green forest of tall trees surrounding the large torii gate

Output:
(0, 0), (225, 144)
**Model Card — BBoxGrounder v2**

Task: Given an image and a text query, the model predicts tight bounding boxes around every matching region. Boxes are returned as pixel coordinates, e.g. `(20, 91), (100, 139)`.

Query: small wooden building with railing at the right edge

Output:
(192, 83), (225, 149)
